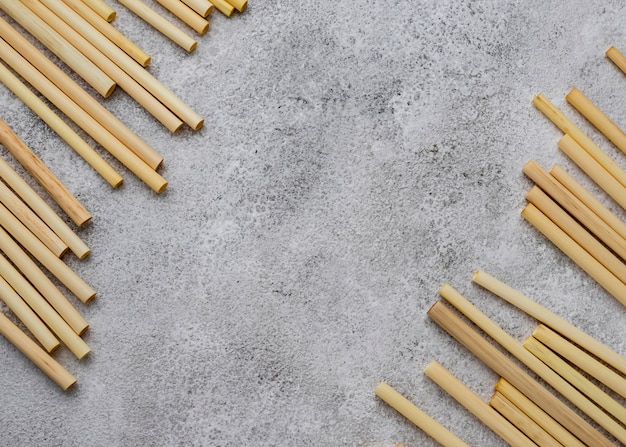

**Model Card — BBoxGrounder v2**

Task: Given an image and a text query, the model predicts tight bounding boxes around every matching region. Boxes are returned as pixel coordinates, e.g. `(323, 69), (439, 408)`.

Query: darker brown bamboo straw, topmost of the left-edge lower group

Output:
(0, 119), (91, 226)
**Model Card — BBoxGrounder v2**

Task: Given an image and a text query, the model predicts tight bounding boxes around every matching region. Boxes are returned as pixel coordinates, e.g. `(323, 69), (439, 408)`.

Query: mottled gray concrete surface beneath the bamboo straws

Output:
(0, 0), (626, 447)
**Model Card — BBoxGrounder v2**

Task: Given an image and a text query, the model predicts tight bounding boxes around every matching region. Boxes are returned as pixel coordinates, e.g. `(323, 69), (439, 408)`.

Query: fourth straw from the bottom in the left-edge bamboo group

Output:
(0, 227), (89, 335)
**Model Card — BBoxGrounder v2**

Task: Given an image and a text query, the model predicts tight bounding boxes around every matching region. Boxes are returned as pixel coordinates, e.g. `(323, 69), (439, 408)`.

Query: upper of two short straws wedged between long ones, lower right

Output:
(533, 324), (626, 397)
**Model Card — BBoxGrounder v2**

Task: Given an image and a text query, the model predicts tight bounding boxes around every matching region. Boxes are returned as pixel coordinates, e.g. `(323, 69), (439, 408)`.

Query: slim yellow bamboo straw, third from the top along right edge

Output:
(533, 94), (626, 191)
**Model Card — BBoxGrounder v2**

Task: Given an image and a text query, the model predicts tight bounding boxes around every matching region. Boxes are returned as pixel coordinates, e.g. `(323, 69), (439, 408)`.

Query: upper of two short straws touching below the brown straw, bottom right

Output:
(494, 378), (585, 447)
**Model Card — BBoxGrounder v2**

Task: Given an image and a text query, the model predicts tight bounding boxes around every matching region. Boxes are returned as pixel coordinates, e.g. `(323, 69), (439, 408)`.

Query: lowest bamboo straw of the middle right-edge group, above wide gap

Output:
(522, 204), (626, 306)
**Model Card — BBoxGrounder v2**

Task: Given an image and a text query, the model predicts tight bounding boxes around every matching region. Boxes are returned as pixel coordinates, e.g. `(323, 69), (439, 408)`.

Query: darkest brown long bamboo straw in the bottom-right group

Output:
(428, 301), (613, 446)
